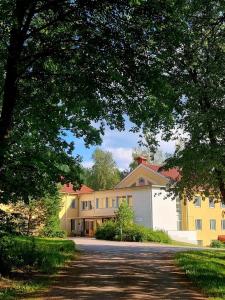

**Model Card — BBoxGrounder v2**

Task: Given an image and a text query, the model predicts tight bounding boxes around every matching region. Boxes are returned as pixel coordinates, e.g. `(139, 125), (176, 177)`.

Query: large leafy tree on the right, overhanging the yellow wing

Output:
(137, 0), (225, 202)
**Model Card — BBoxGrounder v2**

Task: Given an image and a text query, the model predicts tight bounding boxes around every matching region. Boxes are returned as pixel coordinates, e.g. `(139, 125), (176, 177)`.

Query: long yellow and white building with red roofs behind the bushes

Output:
(60, 157), (225, 246)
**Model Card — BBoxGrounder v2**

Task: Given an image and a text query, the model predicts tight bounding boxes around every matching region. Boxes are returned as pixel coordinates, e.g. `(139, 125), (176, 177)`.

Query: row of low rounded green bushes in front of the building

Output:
(95, 220), (171, 243)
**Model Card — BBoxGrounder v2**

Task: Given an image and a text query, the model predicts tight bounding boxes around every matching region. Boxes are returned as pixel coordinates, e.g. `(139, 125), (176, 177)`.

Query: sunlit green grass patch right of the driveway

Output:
(176, 250), (225, 299)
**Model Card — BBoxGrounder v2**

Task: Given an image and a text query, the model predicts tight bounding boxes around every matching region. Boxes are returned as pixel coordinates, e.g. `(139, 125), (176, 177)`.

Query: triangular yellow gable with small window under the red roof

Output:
(116, 164), (168, 188)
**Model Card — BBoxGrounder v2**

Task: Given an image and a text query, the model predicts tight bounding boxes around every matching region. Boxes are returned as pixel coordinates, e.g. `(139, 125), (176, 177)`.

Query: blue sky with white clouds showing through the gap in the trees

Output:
(68, 119), (175, 170)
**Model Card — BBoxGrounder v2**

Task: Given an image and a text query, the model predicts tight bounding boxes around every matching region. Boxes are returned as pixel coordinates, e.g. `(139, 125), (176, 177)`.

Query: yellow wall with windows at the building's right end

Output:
(183, 195), (225, 246)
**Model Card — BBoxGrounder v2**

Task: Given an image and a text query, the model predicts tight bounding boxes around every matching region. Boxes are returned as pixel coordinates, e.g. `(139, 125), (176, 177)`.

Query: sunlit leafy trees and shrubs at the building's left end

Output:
(0, 193), (62, 237)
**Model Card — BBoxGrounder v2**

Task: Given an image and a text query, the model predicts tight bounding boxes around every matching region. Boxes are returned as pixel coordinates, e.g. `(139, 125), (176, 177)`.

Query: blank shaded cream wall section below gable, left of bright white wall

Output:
(132, 187), (152, 228)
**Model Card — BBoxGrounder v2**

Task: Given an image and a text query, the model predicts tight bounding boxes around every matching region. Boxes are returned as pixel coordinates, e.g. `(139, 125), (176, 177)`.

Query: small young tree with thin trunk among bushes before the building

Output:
(115, 202), (134, 241)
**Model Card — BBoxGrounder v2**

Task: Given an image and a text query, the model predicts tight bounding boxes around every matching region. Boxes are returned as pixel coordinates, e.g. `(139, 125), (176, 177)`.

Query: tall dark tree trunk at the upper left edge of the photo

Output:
(0, 0), (34, 171)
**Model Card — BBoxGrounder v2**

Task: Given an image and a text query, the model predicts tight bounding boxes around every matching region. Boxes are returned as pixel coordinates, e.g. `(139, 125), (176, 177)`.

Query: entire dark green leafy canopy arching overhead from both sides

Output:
(0, 0), (225, 201)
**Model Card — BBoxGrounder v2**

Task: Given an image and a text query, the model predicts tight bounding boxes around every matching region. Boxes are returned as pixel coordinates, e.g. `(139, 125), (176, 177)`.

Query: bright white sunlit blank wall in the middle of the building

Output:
(152, 187), (178, 231)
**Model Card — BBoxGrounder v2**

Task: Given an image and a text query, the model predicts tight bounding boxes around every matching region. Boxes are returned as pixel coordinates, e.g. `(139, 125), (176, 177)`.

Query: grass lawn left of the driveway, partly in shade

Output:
(0, 237), (75, 300)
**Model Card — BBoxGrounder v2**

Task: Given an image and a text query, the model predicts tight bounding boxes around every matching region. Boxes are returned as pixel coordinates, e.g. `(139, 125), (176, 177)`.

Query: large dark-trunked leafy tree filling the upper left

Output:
(0, 0), (173, 202)
